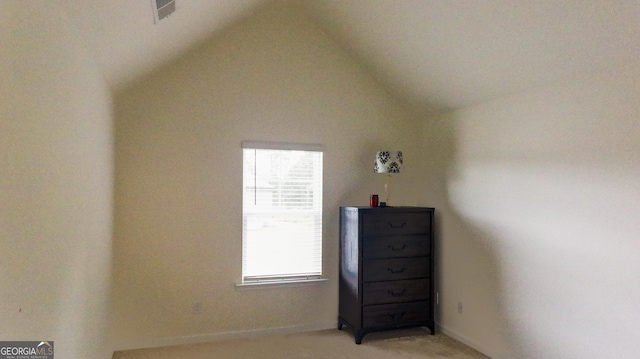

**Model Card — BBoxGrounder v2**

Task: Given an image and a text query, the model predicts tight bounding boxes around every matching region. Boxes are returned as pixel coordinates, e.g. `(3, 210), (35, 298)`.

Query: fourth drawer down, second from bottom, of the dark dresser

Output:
(362, 279), (429, 305)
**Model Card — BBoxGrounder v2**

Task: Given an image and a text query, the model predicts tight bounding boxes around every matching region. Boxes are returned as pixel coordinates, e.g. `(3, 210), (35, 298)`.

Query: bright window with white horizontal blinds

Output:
(242, 142), (322, 283)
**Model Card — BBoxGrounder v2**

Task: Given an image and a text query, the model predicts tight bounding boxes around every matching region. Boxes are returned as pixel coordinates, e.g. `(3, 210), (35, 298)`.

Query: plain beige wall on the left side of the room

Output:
(0, 1), (113, 359)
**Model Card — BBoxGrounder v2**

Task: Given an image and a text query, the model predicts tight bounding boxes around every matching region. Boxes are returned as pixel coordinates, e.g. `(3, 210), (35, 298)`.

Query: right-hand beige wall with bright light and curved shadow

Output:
(425, 65), (640, 358)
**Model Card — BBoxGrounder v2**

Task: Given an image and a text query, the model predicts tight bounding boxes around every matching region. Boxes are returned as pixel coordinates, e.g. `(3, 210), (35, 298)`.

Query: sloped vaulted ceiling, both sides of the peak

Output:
(61, 0), (640, 112)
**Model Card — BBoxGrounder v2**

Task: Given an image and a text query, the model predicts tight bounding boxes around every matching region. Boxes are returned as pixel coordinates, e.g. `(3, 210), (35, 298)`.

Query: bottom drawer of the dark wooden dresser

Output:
(362, 301), (430, 327)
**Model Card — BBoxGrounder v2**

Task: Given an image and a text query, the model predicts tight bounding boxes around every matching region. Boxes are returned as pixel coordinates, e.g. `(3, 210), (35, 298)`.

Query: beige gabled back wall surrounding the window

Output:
(114, 2), (422, 348)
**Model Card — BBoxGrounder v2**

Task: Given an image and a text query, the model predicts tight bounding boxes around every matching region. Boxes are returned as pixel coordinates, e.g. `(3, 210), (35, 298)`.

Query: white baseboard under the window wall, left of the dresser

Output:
(114, 321), (338, 351)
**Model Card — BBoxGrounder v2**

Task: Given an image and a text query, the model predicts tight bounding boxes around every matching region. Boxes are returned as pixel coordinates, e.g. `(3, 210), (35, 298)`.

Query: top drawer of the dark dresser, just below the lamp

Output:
(362, 211), (431, 236)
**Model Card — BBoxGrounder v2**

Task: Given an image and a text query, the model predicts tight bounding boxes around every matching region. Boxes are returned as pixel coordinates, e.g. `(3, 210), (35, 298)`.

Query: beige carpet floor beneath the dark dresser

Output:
(113, 327), (488, 359)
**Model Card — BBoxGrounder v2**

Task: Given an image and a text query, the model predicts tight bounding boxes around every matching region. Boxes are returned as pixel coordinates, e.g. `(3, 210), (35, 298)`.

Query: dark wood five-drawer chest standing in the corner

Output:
(338, 207), (435, 344)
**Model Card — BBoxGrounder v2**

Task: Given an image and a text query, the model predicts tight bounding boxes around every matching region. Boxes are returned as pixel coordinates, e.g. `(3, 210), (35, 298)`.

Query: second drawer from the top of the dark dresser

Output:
(362, 235), (431, 259)
